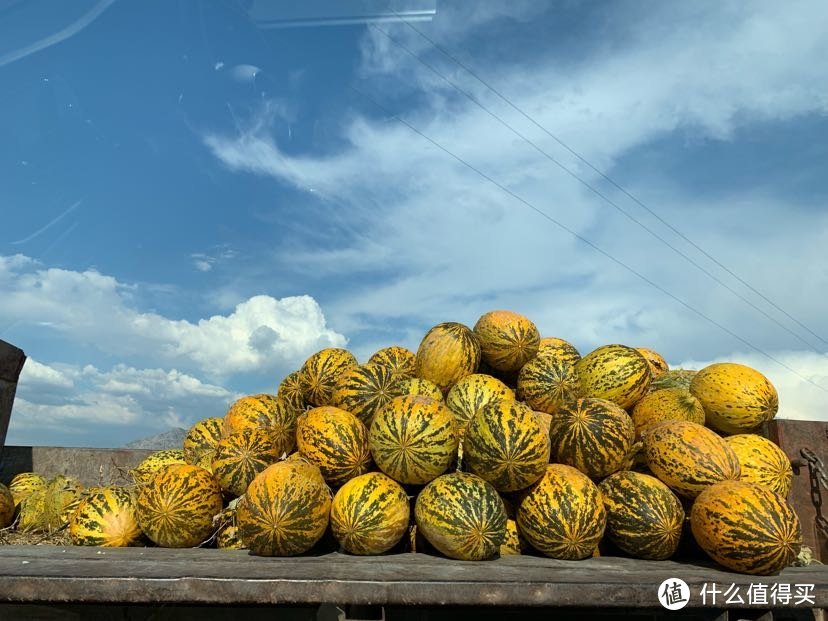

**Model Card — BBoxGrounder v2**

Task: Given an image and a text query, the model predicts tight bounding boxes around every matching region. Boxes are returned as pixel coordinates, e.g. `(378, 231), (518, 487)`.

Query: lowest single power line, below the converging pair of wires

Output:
(349, 85), (828, 392)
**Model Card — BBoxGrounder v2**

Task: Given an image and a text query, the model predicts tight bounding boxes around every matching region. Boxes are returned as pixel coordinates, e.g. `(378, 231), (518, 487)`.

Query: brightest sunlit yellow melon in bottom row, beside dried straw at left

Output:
(69, 487), (142, 548)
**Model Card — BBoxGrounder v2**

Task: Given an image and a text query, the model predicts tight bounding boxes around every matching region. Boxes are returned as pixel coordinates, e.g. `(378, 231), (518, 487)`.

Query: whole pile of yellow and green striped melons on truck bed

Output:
(0, 311), (802, 574)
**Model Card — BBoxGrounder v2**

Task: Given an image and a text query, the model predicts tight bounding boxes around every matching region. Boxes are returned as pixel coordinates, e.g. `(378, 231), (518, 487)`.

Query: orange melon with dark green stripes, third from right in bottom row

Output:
(517, 464), (607, 560)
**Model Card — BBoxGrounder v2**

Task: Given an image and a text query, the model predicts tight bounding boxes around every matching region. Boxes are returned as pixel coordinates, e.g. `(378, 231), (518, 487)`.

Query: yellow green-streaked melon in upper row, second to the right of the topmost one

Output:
(575, 345), (651, 410)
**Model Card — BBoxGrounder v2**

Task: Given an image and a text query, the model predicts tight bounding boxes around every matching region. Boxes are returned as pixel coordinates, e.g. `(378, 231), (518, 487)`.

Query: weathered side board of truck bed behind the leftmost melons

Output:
(0, 446), (154, 485)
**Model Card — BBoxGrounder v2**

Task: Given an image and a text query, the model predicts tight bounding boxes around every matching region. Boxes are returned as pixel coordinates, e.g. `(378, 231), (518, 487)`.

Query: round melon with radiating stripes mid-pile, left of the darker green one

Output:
(369, 395), (458, 485)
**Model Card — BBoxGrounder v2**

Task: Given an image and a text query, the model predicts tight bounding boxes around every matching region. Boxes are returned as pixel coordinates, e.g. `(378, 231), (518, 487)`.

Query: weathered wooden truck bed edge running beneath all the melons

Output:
(0, 546), (828, 609)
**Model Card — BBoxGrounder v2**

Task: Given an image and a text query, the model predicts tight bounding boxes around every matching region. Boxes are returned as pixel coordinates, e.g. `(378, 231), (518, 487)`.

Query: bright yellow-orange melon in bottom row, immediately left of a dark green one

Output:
(331, 472), (411, 554)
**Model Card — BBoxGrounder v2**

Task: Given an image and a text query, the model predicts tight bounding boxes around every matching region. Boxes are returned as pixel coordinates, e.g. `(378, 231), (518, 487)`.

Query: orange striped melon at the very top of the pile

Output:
(474, 310), (540, 373)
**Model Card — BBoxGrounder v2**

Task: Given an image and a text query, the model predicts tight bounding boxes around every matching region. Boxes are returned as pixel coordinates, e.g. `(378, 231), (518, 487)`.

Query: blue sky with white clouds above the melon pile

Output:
(0, 0), (828, 446)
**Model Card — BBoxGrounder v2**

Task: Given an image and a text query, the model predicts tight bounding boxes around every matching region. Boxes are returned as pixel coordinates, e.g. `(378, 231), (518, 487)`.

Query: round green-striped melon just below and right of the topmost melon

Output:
(517, 355), (584, 414)
